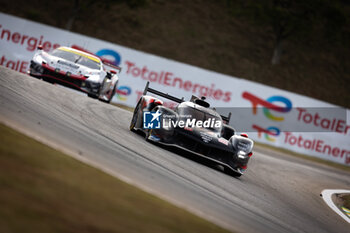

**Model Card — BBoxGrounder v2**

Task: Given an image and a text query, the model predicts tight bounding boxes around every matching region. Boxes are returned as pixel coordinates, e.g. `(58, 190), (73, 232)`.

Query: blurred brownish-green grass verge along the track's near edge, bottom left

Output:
(0, 124), (234, 233)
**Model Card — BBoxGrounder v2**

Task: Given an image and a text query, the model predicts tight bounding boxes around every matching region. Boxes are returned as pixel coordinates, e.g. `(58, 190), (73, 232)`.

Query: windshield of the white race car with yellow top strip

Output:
(51, 49), (100, 69)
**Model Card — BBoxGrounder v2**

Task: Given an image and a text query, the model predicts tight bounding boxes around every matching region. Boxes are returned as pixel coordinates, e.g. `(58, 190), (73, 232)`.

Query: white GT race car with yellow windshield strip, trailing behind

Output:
(29, 46), (121, 103)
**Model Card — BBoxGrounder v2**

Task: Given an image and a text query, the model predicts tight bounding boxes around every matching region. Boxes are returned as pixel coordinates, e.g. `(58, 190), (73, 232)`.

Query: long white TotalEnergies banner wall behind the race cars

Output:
(0, 13), (350, 166)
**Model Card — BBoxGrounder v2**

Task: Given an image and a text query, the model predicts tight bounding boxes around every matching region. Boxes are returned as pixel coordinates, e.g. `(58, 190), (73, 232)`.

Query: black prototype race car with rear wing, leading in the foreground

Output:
(130, 82), (254, 176)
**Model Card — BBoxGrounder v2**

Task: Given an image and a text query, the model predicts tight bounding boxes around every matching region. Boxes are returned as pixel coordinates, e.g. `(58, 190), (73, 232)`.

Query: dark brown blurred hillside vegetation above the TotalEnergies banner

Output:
(0, 0), (350, 108)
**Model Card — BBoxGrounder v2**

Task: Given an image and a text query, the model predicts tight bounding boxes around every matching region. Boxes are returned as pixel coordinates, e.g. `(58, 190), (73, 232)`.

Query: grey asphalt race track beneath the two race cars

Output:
(0, 66), (350, 232)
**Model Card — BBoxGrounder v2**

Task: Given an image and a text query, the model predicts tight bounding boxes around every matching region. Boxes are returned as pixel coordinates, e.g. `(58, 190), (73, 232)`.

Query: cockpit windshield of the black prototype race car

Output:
(177, 107), (222, 132)
